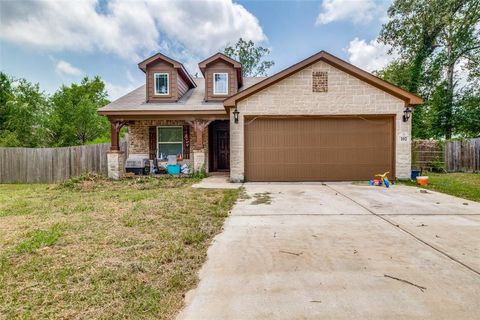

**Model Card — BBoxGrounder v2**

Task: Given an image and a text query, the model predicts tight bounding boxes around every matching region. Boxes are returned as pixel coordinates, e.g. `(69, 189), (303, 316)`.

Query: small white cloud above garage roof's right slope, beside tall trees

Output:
(345, 38), (398, 72)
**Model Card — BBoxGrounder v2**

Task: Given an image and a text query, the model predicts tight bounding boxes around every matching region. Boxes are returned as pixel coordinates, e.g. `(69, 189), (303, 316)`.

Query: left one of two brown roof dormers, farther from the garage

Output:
(138, 53), (197, 102)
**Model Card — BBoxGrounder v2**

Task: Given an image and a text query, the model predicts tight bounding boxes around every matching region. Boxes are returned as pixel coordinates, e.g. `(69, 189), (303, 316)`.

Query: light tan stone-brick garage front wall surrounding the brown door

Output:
(230, 61), (411, 181)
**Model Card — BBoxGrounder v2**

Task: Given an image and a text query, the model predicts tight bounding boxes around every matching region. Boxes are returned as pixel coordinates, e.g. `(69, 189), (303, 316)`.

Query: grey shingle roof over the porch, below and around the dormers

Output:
(98, 77), (265, 114)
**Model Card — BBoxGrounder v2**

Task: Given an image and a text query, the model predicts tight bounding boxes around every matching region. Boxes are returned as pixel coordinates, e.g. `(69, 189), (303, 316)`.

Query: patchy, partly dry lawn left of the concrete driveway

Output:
(0, 177), (238, 319)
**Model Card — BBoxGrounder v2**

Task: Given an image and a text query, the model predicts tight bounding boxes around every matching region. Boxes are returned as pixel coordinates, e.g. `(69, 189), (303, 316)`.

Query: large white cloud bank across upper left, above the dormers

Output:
(0, 0), (266, 61)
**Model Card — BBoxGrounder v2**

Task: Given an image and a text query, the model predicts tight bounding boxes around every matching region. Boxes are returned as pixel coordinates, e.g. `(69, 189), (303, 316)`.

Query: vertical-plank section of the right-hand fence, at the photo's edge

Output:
(445, 138), (480, 172)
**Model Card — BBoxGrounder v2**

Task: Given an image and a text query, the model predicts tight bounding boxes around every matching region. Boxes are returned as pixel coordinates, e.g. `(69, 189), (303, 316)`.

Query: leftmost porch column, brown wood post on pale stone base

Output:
(107, 121), (125, 180)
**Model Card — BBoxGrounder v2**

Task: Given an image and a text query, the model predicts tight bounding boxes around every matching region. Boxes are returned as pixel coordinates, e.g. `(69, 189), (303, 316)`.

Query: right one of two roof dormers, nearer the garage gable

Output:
(198, 53), (243, 101)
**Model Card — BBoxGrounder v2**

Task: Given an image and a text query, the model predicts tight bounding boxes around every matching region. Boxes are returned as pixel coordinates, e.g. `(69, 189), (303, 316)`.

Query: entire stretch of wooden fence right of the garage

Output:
(412, 138), (480, 172)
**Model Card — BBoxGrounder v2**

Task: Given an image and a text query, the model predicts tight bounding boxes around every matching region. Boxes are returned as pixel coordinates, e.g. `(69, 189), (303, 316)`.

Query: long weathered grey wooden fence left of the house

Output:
(0, 140), (127, 183)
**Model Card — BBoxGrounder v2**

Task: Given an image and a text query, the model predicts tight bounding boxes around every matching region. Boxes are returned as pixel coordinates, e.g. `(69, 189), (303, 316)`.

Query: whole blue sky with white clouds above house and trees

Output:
(0, 0), (394, 100)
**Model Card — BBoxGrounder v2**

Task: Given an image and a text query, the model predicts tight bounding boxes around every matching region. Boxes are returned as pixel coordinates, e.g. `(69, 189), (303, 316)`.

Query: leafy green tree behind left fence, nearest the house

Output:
(49, 77), (109, 146)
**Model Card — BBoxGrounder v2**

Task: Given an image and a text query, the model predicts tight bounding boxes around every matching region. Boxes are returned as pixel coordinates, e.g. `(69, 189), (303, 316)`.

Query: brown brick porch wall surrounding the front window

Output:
(128, 120), (208, 169)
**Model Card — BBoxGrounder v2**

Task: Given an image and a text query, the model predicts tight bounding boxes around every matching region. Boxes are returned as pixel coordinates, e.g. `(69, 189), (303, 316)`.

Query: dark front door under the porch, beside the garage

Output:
(209, 121), (230, 171)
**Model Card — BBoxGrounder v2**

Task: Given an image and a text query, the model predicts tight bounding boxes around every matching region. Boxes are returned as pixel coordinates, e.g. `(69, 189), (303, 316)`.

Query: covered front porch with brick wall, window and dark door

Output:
(107, 118), (230, 179)
